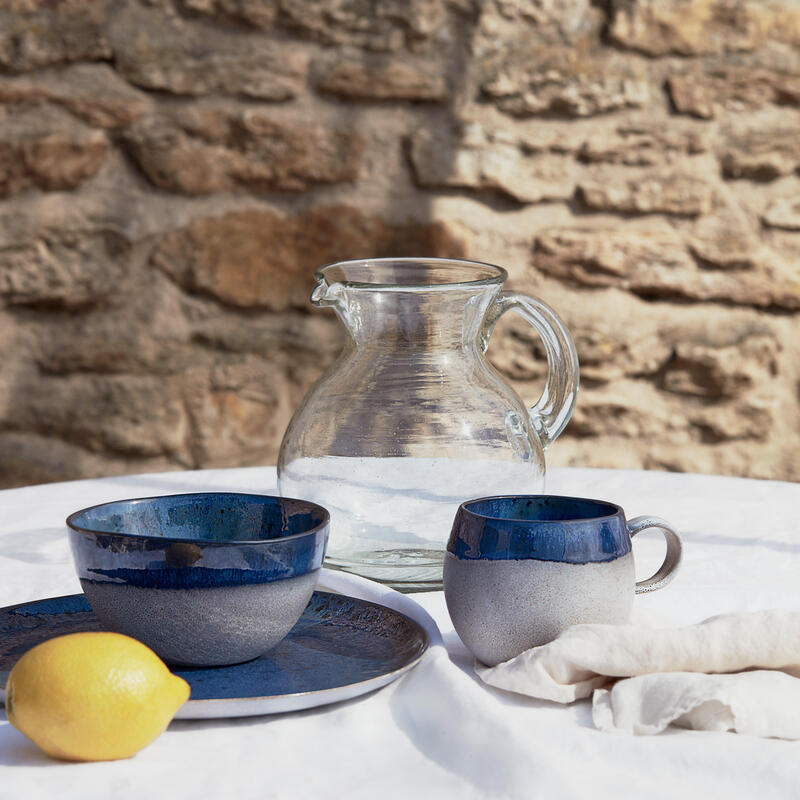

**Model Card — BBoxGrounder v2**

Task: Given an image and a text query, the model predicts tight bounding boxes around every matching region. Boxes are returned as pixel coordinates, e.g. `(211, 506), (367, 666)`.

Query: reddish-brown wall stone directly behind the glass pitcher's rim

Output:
(153, 206), (462, 311)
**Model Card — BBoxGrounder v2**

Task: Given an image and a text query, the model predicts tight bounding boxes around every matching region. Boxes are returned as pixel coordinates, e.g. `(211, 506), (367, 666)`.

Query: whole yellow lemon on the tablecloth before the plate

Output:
(6, 633), (189, 761)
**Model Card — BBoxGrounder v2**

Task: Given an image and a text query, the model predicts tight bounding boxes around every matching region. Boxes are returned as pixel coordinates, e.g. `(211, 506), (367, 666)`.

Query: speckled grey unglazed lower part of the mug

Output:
(444, 553), (634, 666)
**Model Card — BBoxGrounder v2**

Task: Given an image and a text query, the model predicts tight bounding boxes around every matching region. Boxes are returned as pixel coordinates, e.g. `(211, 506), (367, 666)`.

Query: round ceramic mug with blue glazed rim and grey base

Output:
(444, 495), (681, 665)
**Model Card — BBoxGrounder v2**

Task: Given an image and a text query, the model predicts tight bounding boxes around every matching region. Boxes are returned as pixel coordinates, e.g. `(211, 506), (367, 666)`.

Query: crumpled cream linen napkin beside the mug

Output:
(475, 610), (800, 739)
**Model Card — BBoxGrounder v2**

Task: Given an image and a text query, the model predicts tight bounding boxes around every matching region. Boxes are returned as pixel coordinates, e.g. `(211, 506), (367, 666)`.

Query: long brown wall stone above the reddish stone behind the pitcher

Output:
(125, 108), (361, 194)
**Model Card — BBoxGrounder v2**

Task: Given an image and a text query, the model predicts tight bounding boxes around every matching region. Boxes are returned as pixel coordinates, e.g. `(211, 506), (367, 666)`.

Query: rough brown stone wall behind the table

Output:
(0, 0), (800, 486)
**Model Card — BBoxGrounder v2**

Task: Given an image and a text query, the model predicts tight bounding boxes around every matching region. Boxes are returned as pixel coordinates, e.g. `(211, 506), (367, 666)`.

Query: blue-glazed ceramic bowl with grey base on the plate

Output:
(67, 492), (330, 666)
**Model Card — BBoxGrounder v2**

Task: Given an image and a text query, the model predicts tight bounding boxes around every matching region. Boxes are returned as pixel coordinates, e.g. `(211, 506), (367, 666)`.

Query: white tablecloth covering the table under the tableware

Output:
(0, 467), (800, 800)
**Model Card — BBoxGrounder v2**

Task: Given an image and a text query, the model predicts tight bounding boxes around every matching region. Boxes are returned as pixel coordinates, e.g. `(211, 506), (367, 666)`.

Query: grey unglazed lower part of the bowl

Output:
(81, 570), (319, 667)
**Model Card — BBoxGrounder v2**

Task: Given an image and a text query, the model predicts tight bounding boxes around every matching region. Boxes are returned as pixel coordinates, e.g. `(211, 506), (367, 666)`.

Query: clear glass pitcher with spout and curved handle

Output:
(278, 258), (578, 591)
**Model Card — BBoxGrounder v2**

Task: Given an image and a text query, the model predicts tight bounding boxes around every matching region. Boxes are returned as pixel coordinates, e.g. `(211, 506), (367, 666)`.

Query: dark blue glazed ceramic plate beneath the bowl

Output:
(0, 592), (428, 719)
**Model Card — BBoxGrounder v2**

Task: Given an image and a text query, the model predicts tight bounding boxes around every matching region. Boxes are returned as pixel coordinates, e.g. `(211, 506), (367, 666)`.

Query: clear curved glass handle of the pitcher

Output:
(479, 292), (580, 449)
